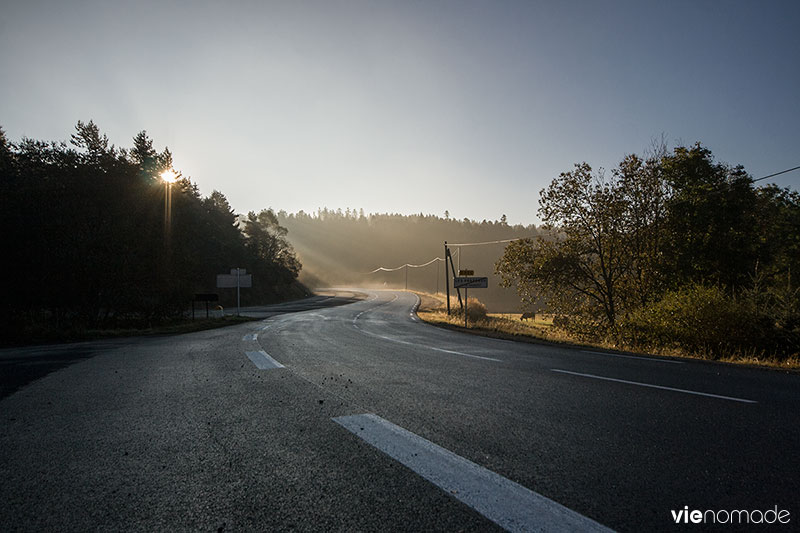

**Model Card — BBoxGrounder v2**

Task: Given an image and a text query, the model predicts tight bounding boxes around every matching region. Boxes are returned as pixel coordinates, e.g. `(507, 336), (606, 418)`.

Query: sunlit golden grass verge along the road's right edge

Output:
(416, 292), (800, 371)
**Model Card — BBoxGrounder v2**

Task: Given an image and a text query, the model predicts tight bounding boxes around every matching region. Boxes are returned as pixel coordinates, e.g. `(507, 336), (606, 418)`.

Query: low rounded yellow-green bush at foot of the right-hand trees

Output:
(620, 284), (796, 359)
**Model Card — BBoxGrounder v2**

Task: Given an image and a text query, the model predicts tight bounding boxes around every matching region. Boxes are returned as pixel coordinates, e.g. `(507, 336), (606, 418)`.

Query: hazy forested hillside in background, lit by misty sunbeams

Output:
(277, 208), (537, 312)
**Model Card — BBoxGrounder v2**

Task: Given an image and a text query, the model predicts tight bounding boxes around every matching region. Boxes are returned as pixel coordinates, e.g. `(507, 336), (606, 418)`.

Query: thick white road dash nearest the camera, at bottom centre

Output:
(333, 414), (610, 531)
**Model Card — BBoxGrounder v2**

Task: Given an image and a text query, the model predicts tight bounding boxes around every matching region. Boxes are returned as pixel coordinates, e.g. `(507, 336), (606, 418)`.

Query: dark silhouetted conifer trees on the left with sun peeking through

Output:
(0, 121), (303, 339)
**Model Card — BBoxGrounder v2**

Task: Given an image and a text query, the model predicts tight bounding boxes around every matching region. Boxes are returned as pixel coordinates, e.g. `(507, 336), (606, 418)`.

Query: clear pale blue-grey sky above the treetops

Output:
(0, 0), (800, 224)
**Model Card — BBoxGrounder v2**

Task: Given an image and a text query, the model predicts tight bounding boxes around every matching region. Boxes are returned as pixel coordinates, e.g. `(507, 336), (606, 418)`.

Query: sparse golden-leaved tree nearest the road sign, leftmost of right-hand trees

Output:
(496, 163), (630, 330)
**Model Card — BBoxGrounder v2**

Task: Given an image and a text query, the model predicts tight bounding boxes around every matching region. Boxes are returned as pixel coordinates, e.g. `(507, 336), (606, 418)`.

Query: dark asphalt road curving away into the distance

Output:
(0, 291), (800, 531)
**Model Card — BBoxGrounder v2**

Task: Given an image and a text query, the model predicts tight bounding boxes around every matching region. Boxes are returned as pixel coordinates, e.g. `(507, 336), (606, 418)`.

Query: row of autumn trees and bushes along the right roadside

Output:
(496, 143), (800, 357)
